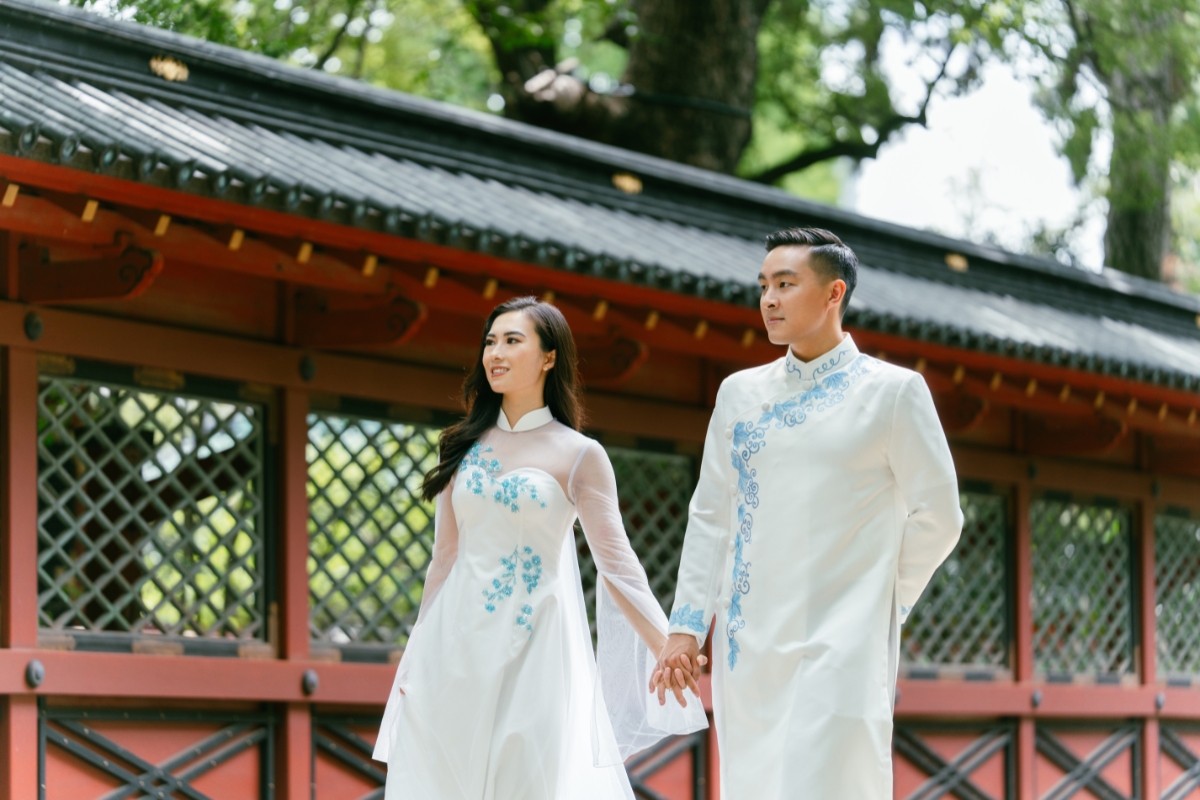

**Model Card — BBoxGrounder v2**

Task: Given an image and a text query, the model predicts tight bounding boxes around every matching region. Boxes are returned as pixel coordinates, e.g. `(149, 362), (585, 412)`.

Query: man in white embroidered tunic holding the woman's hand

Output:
(654, 228), (962, 800)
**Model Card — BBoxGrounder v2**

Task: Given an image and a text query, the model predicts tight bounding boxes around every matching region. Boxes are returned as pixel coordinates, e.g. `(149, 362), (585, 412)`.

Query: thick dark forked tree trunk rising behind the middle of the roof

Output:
(468, 0), (770, 173)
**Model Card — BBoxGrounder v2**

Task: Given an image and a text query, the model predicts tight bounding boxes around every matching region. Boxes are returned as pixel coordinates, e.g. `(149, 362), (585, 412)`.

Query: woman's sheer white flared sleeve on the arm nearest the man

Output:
(568, 441), (708, 765)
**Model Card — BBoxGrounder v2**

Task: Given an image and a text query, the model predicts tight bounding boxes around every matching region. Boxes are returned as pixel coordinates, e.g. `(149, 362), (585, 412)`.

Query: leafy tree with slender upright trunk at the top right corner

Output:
(992, 0), (1200, 279)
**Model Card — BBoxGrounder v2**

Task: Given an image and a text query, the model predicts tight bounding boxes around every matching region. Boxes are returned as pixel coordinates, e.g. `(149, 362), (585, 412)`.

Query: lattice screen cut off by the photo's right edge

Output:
(1154, 510), (1200, 682)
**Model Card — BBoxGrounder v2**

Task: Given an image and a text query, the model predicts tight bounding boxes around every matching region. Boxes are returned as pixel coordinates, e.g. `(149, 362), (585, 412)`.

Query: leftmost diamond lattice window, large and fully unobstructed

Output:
(37, 378), (264, 638)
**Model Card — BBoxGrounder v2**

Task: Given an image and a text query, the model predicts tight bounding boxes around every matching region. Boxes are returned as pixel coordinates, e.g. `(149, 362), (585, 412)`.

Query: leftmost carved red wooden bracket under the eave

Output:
(19, 247), (162, 302)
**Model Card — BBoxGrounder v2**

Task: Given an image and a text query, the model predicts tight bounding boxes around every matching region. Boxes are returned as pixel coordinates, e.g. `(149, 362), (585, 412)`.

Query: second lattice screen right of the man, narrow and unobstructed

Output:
(1030, 495), (1134, 681)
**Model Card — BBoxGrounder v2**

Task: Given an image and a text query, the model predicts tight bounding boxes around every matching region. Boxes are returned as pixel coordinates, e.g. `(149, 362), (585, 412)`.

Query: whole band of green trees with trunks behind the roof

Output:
(72, 0), (1200, 277)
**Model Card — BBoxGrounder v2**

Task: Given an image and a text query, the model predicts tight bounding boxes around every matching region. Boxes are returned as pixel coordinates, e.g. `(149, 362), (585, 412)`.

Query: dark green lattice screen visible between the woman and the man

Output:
(575, 447), (696, 619)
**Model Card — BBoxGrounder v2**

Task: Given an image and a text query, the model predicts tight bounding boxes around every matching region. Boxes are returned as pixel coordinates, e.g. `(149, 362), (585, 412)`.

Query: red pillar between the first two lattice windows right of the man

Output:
(1013, 481), (1037, 800)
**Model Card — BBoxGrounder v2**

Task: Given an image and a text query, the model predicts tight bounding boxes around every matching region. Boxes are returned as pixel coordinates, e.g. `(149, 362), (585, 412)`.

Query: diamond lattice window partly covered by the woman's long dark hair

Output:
(307, 414), (438, 645)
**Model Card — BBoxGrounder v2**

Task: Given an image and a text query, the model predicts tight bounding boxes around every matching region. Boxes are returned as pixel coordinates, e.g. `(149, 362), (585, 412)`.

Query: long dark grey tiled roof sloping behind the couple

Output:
(0, 0), (1200, 391)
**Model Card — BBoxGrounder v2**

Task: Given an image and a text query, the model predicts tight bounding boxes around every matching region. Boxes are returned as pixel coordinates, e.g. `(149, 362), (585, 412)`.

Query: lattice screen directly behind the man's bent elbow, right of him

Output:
(900, 491), (1008, 676)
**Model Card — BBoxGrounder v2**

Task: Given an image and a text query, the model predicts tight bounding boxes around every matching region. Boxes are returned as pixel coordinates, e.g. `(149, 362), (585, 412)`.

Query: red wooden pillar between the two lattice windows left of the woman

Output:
(276, 389), (320, 800)
